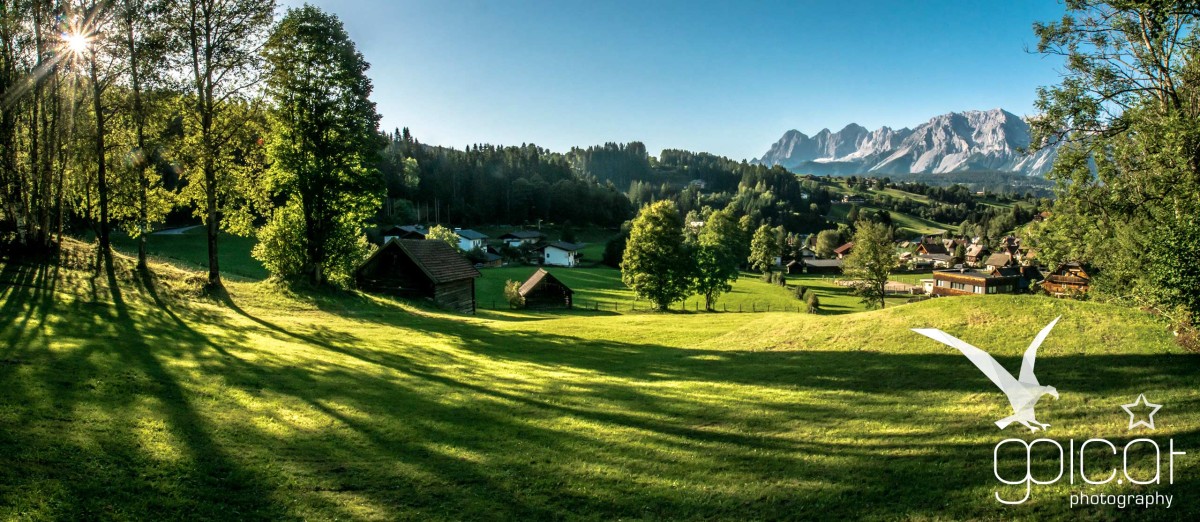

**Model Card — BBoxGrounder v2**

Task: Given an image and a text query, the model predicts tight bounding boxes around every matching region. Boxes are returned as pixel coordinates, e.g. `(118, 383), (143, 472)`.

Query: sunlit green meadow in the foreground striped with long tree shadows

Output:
(0, 247), (1200, 520)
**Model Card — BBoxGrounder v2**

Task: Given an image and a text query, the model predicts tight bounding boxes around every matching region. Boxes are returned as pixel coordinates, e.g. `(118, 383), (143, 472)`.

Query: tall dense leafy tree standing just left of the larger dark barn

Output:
(264, 5), (384, 284)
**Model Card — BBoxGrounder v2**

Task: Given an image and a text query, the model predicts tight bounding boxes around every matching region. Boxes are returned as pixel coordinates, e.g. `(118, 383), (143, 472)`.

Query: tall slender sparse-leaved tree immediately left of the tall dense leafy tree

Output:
(170, 0), (275, 292)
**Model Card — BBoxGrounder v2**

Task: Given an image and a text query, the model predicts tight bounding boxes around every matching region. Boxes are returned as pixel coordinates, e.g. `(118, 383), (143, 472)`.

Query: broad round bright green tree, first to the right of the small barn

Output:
(620, 200), (694, 310)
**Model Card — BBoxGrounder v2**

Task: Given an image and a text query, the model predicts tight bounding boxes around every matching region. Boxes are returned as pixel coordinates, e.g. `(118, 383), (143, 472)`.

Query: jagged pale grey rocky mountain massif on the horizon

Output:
(755, 109), (1055, 175)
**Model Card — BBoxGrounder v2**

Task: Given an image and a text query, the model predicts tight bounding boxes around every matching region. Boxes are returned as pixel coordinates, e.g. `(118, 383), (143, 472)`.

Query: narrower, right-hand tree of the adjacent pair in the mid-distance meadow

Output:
(695, 210), (742, 311)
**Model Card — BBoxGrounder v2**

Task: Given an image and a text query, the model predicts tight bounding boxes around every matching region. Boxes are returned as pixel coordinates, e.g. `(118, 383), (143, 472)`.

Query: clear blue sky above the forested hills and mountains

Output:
(283, 0), (1063, 160)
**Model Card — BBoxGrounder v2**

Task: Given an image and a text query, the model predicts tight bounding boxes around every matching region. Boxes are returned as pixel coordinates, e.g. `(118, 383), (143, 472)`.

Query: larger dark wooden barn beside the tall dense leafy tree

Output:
(354, 239), (480, 313)
